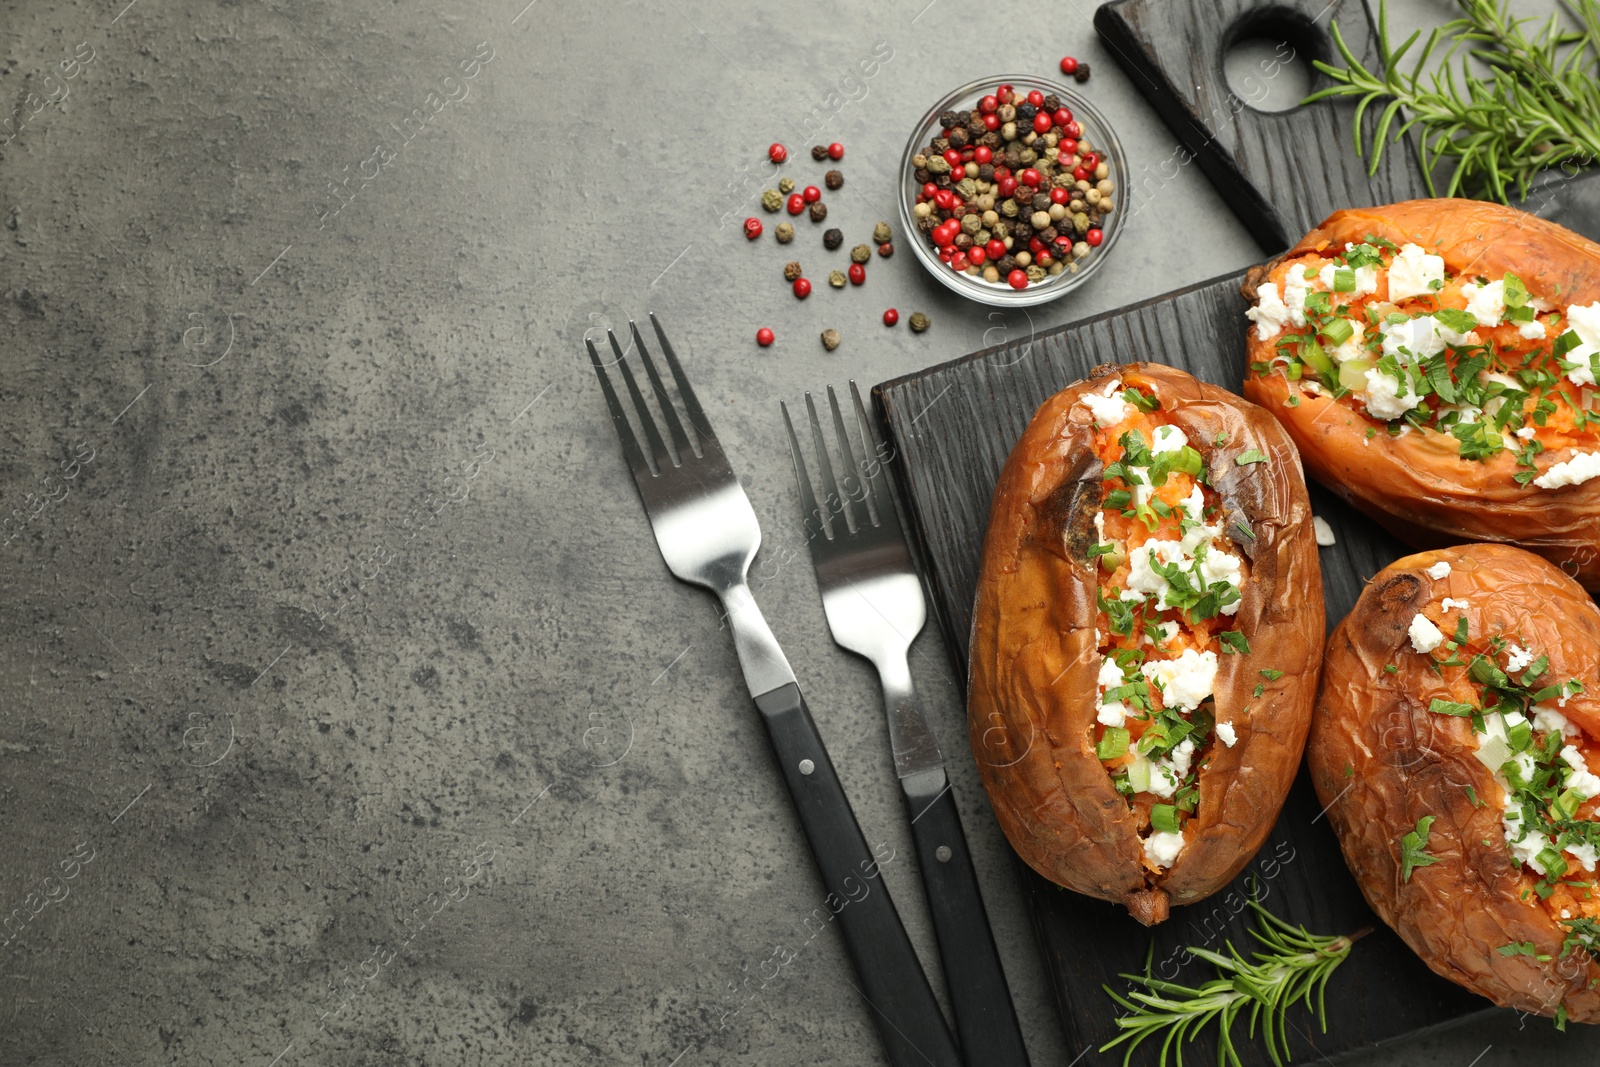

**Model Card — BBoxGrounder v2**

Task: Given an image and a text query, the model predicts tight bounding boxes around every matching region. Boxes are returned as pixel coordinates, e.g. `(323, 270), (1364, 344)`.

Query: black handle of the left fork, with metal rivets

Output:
(755, 683), (962, 1067)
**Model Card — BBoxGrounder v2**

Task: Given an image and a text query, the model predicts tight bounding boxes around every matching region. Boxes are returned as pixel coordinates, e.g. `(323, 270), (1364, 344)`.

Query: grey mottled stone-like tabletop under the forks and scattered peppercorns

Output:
(0, 0), (1595, 1067)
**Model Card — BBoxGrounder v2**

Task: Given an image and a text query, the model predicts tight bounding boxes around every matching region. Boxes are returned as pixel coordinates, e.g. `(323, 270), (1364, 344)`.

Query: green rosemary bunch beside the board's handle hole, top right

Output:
(1304, 0), (1600, 203)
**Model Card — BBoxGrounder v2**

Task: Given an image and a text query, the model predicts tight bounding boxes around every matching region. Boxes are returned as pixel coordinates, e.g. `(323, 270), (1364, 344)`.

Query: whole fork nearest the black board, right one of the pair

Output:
(779, 382), (1029, 1067)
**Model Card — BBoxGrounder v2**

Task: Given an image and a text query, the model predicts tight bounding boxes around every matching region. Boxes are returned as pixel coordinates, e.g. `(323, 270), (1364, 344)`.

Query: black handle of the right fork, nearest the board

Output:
(901, 766), (1029, 1067)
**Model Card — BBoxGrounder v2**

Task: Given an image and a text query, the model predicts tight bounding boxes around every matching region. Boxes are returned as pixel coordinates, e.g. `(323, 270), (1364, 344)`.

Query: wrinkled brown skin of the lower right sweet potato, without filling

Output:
(1306, 544), (1600, 1022)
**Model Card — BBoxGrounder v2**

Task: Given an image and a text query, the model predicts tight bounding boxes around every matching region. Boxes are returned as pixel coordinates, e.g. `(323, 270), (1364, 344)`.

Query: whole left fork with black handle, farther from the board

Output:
(586, 315), (962, 1067)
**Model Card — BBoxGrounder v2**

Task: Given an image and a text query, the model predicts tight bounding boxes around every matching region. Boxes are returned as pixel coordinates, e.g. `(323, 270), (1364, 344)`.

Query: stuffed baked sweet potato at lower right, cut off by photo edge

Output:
(1306, 544), (1600, 1022)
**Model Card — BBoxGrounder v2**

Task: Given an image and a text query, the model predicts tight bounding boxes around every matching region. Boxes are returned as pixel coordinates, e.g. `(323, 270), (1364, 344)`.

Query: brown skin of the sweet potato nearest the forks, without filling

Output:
(968, 363), (1323, 925)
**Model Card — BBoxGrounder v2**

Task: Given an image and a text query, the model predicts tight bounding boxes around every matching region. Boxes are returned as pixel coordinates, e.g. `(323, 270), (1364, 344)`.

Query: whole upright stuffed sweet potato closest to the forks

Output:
(968, 363), (1323, 925)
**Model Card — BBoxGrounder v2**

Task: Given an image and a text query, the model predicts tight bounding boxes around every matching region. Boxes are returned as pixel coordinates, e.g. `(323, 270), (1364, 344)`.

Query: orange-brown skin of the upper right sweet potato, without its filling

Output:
(1243, 200), (1600, 590)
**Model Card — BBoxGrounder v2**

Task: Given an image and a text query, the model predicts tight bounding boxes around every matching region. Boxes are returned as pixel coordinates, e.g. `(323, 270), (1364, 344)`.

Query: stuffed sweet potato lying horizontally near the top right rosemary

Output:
(1245, 200), (1600, 589)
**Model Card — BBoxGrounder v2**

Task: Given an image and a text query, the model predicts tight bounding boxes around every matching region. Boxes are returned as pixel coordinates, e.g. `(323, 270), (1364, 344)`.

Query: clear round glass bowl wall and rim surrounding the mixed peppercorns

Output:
(899, 74), (1128, 307)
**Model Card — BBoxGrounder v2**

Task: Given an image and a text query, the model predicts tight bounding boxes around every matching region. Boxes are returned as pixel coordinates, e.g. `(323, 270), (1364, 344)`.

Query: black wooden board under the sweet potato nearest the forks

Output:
(872, 274), (1490, 1067)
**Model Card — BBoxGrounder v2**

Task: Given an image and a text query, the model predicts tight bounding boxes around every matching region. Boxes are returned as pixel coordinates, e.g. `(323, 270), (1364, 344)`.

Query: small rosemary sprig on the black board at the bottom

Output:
(1099, 899), (1371, 1067)
